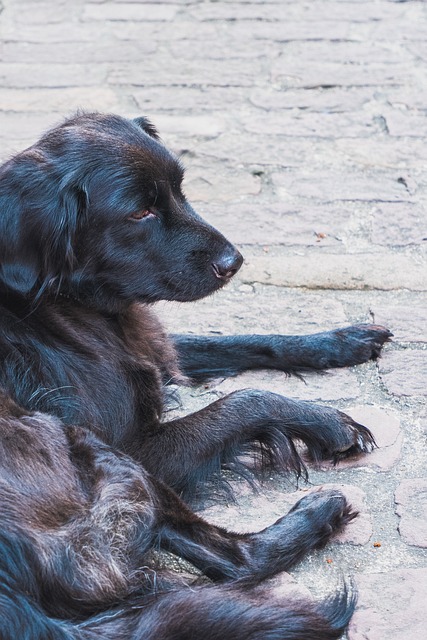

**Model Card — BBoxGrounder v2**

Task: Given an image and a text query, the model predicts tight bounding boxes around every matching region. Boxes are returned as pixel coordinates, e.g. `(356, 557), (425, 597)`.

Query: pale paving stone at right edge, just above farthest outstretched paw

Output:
(371, 302), (427, 343)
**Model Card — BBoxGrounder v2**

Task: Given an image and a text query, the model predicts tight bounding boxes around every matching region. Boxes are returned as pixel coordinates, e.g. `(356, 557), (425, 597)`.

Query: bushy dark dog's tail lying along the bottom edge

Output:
(79, 585), (356, 640)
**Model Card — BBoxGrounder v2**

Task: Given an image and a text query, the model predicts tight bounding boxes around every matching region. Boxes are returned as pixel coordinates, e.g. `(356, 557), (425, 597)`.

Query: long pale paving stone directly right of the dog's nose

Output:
(239, 255), (427, 291)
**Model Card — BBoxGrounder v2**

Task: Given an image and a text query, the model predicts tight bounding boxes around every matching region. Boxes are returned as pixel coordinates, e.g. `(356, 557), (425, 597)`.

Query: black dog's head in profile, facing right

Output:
(0, 114), (242, 311)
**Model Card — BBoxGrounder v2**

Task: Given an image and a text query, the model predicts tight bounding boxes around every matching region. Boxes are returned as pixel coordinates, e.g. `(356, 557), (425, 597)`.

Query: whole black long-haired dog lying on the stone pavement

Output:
(0, 114), (391, 640)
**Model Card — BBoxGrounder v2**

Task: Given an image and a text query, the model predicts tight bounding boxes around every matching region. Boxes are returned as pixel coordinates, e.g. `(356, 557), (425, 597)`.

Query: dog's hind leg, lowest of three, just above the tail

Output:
(155, 483), (357, 585)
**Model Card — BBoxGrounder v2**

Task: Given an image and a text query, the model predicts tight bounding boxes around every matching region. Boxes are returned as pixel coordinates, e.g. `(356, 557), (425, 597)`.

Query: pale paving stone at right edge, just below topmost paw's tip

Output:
(379, 349), (427, 397)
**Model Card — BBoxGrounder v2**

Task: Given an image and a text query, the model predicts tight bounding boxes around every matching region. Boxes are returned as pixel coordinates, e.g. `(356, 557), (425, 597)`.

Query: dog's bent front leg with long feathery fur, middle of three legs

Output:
(140, 389), (375, 491)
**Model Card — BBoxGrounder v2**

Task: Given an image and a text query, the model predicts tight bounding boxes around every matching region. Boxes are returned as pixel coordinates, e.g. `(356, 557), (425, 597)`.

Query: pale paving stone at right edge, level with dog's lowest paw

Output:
(395, 478), (427, 548)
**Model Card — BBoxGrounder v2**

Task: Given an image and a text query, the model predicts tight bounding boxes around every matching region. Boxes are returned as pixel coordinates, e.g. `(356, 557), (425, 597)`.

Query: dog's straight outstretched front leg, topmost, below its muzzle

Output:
(172, 324), (392, 381)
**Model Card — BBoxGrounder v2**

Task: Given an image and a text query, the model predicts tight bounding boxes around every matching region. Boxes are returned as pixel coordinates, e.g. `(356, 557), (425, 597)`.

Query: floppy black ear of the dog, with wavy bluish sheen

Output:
(0, 156), (86, 296)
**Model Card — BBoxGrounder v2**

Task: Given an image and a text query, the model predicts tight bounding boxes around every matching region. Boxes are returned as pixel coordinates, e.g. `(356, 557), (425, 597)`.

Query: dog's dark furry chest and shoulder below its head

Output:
(0, 302), (162, 448)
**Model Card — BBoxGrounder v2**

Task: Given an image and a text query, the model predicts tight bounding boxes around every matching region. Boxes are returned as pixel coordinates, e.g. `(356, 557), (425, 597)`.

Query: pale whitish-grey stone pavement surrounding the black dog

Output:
(0, 0), (427, 640)
